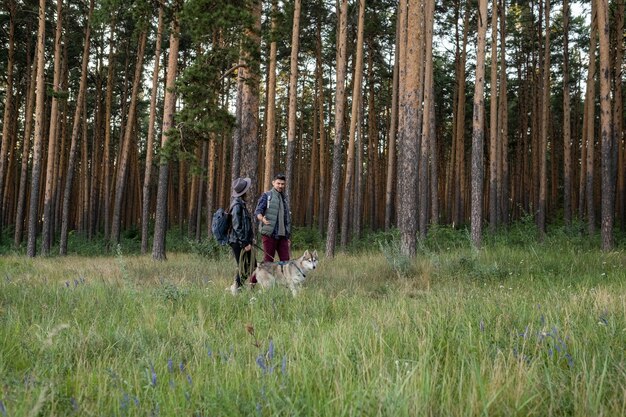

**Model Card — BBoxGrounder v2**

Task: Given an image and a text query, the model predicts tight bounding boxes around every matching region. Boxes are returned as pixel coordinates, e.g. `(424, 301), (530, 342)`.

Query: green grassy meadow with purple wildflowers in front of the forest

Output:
(0, 226), (626, 416)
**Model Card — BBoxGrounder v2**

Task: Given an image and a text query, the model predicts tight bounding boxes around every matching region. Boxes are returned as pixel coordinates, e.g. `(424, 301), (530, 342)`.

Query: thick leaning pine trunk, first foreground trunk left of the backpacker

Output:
(152, 6), (182, 260)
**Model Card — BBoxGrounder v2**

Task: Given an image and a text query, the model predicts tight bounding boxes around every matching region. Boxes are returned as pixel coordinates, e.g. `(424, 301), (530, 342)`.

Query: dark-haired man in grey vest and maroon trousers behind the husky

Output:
(254, 174), (291, 262)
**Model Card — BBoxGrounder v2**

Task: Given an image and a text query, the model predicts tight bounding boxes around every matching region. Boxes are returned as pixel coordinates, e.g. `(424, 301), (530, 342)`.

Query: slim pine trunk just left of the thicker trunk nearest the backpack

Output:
(141, 6), (163, 255)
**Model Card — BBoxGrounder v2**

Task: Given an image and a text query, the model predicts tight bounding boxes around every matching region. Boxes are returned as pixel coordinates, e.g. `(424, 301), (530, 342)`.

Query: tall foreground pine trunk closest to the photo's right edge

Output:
(597, 0), (612, 251)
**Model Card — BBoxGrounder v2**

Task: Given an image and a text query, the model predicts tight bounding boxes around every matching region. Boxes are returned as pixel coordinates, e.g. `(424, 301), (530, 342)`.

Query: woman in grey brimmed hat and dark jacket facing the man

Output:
(228, 178), (254, 294)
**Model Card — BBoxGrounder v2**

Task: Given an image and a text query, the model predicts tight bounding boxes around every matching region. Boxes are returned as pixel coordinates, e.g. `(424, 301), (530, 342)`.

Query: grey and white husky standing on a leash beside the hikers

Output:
(254, 250), (319, 296)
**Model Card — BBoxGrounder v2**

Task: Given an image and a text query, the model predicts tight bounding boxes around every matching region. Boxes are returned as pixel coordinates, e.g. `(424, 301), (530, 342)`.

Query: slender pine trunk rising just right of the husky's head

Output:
(326, 0), (348, 258)
